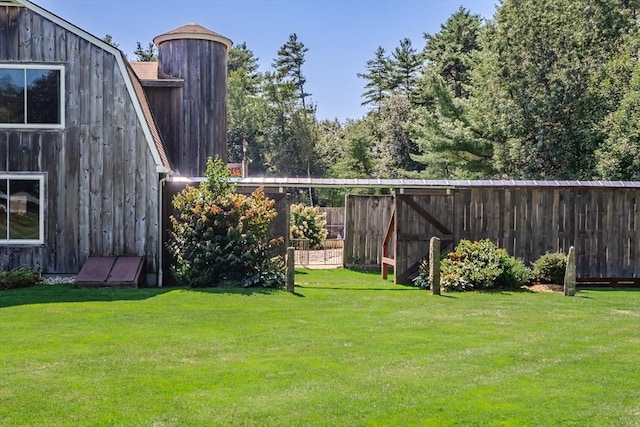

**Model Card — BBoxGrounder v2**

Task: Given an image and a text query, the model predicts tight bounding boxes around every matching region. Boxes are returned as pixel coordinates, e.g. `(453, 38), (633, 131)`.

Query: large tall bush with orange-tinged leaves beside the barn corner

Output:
(168, 157), (284, 287)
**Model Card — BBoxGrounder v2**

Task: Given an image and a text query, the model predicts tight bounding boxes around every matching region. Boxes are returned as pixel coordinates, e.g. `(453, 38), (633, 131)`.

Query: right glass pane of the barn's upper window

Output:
(27, 70), (60, 124)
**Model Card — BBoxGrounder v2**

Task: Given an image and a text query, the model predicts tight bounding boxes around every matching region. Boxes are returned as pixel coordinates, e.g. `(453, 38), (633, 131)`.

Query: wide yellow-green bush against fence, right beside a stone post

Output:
(440, 240), (531, 291)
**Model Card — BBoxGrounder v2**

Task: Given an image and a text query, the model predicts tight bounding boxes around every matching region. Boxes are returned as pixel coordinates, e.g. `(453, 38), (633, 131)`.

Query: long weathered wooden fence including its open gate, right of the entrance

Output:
(345, 185), (640, 283)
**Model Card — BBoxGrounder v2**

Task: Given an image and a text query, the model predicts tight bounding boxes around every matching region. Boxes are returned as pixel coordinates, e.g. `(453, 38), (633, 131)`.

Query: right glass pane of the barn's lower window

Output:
(9, 179), (40, 240)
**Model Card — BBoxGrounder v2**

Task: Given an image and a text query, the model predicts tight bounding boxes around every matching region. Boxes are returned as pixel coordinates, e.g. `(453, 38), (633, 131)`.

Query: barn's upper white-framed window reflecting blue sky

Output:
(0, 64), (64, 128)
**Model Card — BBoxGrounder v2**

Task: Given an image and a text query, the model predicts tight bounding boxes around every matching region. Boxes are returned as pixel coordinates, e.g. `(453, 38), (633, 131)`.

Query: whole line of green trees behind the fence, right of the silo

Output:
(228, 0), (640, 191)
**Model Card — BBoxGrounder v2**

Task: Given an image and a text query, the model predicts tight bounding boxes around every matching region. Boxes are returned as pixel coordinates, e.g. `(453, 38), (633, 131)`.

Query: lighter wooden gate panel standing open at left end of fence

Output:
(343, 195), (393, 266)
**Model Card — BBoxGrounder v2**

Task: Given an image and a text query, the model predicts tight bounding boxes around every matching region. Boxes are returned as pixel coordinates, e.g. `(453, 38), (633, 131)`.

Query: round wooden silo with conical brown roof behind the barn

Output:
(153, 24), (231, 176)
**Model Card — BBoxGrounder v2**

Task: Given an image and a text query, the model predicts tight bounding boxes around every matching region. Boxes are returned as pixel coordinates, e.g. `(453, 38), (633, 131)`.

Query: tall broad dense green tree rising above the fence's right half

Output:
(485, 0), (637, 179)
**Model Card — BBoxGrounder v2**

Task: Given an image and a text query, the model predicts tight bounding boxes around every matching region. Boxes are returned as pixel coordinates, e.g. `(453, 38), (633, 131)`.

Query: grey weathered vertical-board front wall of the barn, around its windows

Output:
(0, 7), (158, 273)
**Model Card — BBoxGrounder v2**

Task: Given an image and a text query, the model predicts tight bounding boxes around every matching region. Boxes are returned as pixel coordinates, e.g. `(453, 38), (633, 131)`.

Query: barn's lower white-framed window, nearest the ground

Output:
(0, 174), (44, 244)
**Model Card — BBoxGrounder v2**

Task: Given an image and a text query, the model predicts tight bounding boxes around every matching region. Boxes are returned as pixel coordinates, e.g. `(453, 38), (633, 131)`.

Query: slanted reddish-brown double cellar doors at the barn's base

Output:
(75, 257), (144, 288)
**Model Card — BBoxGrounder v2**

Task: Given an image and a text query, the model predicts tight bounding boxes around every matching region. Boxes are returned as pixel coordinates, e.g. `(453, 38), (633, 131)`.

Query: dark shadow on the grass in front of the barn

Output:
(0, 284), (179, 308)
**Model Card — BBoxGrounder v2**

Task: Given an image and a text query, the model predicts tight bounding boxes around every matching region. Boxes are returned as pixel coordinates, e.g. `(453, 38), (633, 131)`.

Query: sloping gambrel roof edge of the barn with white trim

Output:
(8, 0), (172, 173)
